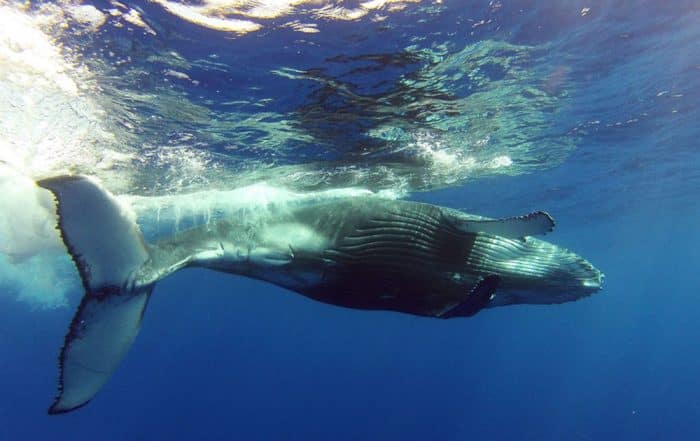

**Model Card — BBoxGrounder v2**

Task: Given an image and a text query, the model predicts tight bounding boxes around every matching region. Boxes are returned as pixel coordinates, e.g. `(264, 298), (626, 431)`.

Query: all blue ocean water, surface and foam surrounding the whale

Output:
(0, 0), (700, 441)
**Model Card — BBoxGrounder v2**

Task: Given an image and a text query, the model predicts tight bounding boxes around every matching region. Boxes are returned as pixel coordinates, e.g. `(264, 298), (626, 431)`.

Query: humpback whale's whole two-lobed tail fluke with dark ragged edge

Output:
(37, 176), (153, 414)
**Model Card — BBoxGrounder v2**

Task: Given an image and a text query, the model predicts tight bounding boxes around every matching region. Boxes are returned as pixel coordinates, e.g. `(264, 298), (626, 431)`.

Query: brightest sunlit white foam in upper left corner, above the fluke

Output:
(0, 5), (126, 183)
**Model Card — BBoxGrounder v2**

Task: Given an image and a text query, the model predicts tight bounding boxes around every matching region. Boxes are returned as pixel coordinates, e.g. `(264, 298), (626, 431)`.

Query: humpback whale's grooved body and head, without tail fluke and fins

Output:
(147, 197), (601, 317)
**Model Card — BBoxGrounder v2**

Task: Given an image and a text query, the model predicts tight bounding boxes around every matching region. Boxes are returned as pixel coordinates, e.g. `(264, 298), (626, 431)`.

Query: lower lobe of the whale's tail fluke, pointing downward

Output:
(48, 287), (152, 414)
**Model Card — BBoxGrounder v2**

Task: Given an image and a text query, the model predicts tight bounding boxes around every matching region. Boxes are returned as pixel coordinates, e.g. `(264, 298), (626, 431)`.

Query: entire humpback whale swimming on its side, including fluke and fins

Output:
(37, 176), (603, 414)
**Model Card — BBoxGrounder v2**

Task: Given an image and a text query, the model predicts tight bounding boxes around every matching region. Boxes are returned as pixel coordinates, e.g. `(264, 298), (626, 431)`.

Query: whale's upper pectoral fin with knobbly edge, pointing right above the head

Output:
(456, 211), (554, 239)
